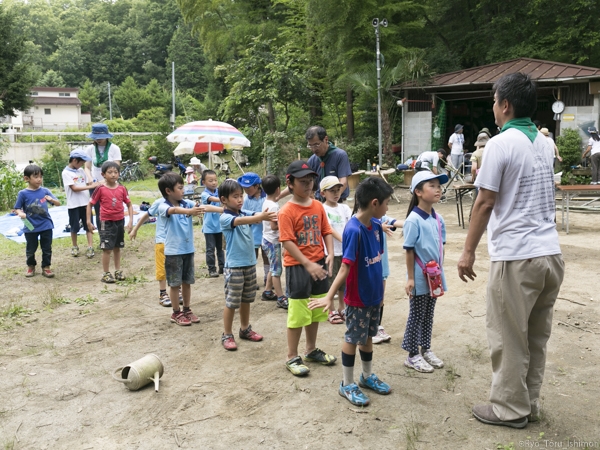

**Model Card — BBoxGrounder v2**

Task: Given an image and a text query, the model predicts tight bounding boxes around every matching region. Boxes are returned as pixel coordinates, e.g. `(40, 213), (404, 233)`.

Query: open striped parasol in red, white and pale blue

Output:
(167, 119), (250, 168)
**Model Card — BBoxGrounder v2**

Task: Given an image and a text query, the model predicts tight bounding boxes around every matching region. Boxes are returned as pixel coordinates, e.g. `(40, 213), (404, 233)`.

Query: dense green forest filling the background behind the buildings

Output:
(0, 0), (600, 163)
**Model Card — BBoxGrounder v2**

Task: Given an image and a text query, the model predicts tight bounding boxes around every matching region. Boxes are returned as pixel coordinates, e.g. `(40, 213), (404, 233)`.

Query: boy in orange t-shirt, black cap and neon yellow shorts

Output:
(278, 161), (336, 376)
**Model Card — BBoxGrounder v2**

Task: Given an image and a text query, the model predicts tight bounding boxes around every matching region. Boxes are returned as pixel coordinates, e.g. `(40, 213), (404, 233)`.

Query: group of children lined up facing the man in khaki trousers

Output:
(15, 151), (447, 406)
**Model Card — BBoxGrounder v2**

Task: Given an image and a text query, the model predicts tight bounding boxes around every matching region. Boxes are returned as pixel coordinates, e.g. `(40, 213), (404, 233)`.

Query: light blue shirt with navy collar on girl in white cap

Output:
(404, 207), (448, 295)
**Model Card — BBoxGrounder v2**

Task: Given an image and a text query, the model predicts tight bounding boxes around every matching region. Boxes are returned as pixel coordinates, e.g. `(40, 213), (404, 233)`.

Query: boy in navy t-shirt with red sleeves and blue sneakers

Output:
(308, 177), (393, 406)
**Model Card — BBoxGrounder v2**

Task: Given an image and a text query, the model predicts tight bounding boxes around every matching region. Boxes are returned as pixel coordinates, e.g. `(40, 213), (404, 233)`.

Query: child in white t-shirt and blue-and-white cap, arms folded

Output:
(62, 150), (99, 258)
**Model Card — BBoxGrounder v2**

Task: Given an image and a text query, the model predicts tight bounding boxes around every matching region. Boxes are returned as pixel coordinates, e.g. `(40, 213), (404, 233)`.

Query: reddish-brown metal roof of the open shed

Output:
(403, 58), (600, 89)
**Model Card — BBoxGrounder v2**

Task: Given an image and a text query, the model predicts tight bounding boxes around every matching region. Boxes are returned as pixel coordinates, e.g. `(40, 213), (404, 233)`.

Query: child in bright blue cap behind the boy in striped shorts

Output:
(237, 172), (270, 300)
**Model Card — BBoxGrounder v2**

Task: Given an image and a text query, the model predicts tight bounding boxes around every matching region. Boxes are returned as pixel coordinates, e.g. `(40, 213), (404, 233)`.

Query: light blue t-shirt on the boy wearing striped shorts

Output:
(221, 209), (262, 268)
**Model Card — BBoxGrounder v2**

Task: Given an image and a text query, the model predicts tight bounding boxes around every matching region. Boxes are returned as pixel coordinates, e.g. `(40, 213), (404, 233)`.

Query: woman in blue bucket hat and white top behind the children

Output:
(85, 123), (121, 226)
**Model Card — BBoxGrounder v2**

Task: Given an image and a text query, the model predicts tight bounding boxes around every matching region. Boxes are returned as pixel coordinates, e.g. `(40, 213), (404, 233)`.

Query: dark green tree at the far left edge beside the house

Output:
(0, 3), (35, 116)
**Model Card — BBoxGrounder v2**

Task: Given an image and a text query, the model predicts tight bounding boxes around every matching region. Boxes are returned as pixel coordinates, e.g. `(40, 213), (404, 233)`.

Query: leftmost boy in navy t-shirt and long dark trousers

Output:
(15, 164), (60, 278)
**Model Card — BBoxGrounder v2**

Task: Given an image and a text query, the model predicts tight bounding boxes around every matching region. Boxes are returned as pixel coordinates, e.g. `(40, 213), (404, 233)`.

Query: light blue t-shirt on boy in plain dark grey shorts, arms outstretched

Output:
(157, 200), (196, 256)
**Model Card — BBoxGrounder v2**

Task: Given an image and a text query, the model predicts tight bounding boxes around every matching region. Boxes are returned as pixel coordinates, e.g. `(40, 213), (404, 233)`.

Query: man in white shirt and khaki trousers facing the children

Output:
(458, 73), (564, 428)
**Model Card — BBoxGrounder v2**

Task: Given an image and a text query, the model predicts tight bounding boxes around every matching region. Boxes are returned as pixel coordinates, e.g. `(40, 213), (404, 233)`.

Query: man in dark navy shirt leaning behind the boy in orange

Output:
(279, 125), (352, 202)
